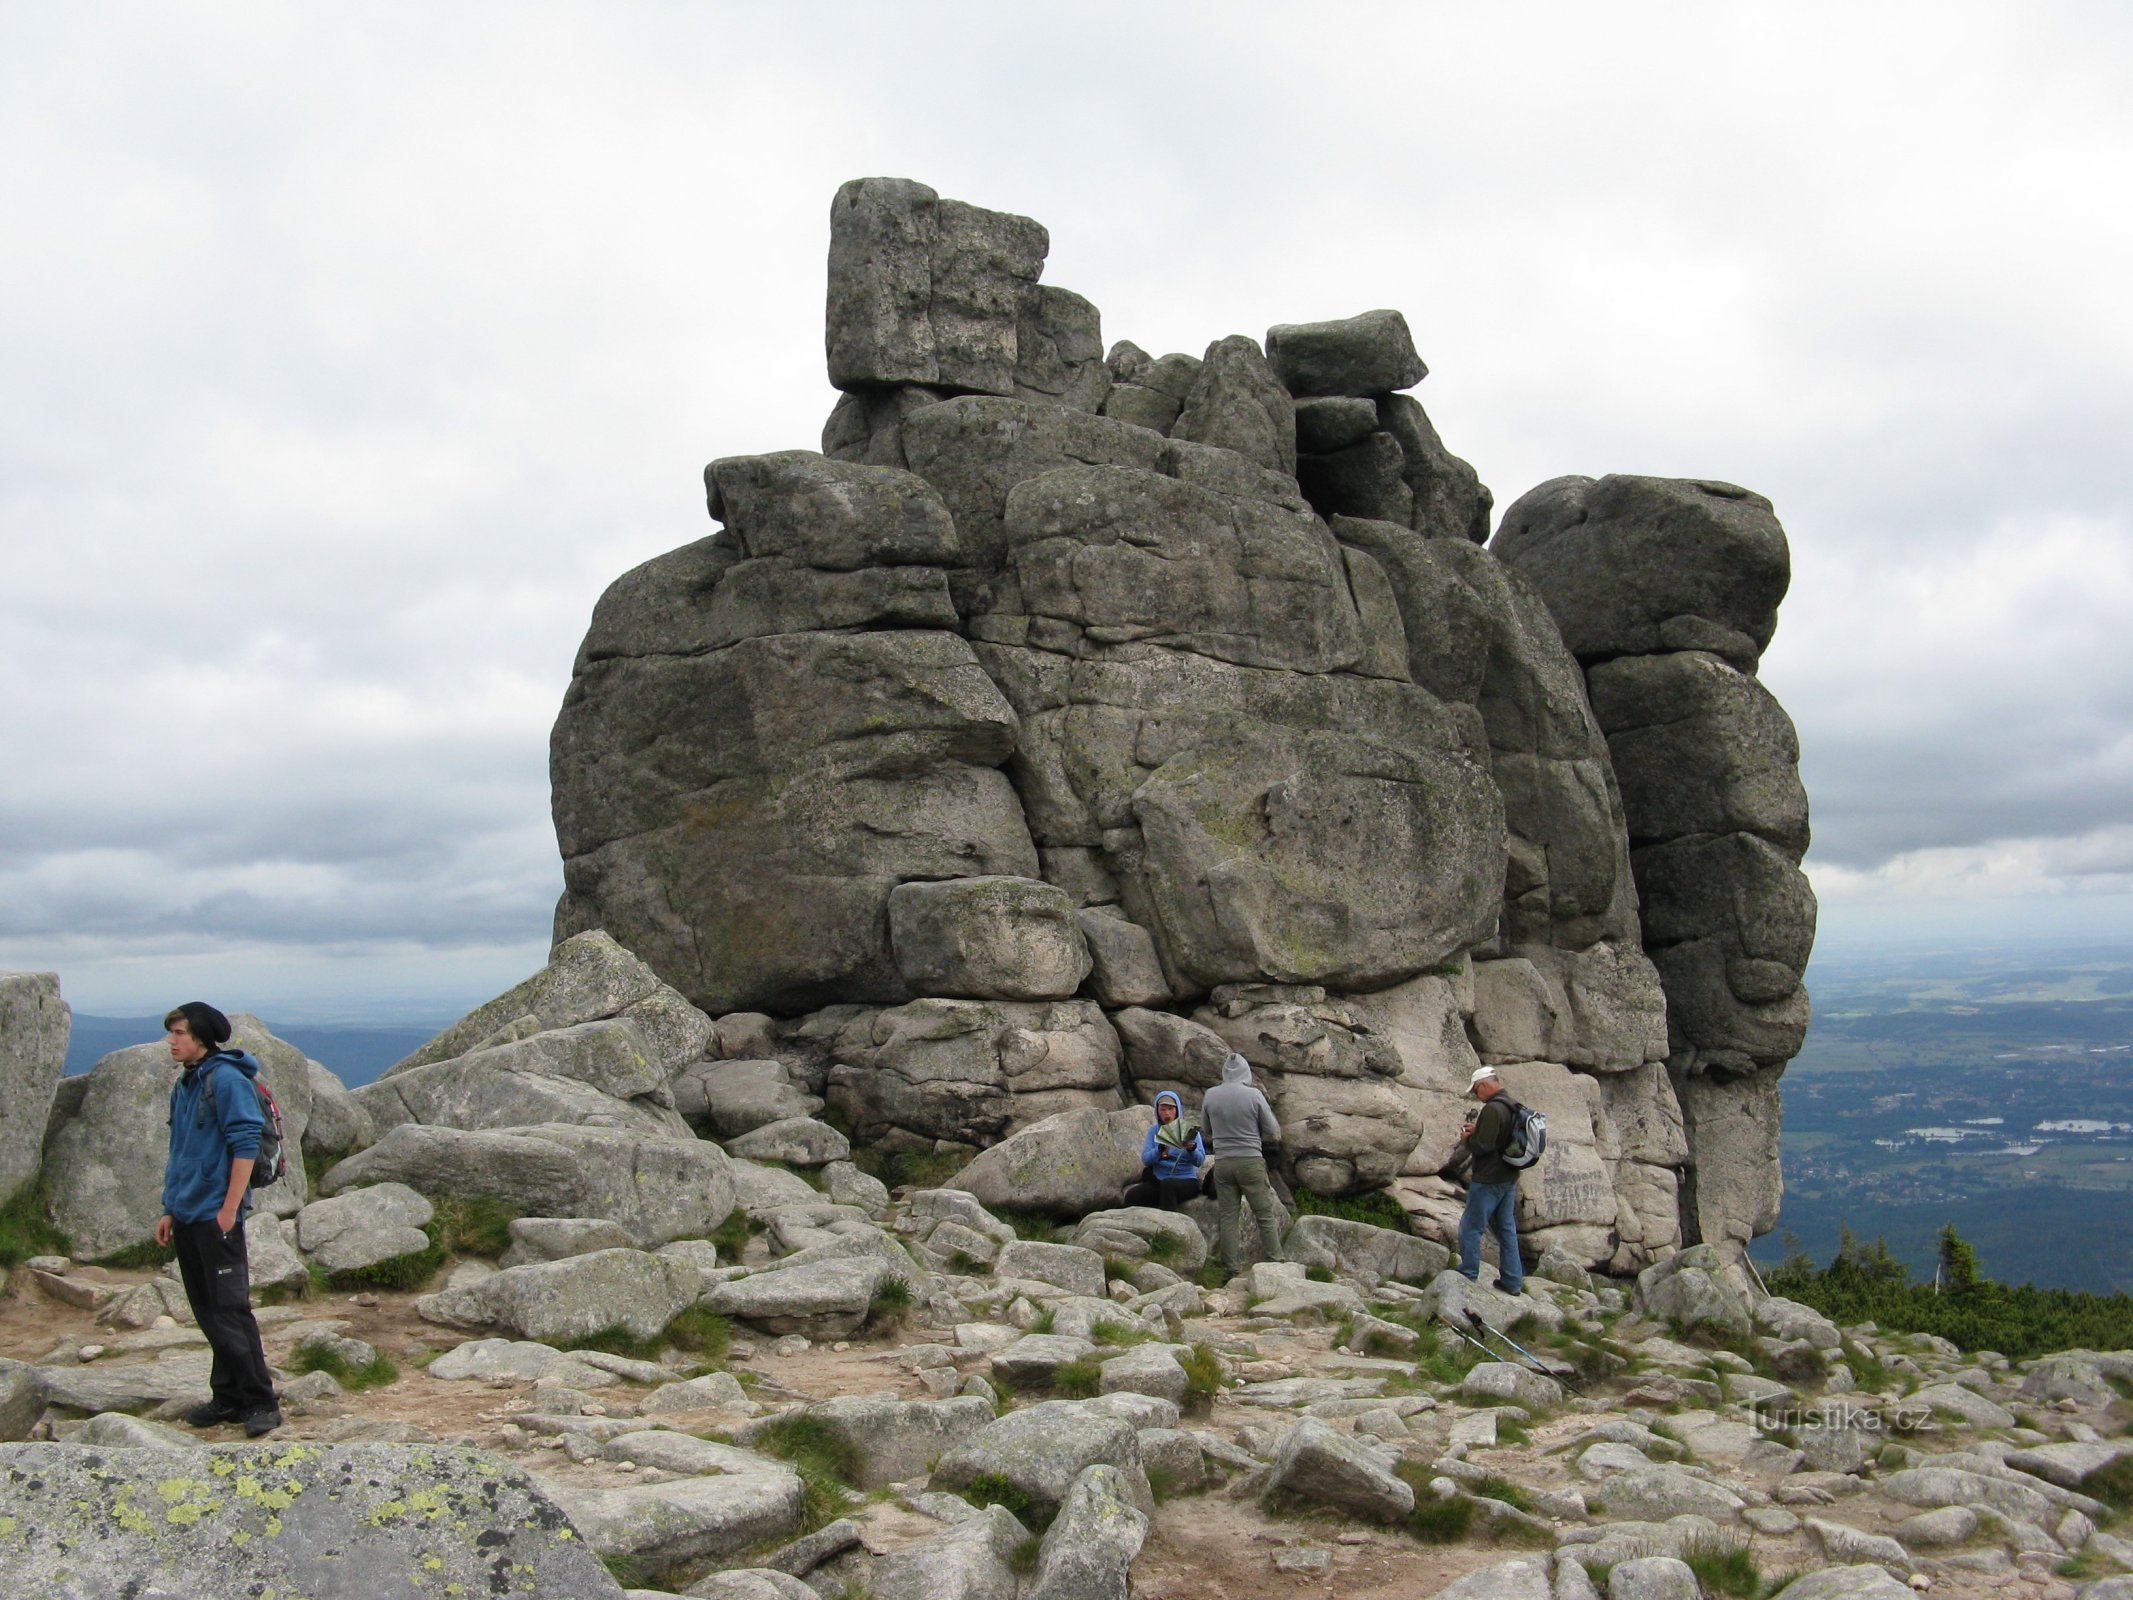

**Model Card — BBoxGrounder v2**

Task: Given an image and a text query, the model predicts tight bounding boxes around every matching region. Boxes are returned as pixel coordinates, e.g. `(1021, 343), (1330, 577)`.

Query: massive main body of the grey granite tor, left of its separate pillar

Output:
(552, 179), (1817, 1267)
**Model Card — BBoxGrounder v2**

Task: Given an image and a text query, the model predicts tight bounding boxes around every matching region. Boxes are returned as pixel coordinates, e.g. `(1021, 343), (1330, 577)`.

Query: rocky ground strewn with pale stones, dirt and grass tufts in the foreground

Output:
(0, 1186), (2133, 1600)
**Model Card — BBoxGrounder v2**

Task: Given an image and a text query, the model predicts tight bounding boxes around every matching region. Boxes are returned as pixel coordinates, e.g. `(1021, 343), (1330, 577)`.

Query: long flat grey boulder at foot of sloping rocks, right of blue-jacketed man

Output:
(320, 1122), (734, 1248)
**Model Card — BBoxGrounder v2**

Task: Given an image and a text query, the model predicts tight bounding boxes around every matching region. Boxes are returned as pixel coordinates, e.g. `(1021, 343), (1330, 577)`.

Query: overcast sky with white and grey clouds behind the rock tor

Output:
(0, 0), (2133, 1018)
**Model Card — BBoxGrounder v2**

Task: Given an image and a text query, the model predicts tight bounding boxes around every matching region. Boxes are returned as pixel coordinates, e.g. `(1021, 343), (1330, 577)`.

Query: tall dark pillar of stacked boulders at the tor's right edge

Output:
(1491, 478), (1815, 1250)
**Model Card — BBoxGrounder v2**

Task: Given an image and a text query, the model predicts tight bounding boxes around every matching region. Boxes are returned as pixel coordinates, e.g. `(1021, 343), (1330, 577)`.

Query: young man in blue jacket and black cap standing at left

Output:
(156, 1001), (282, 1438)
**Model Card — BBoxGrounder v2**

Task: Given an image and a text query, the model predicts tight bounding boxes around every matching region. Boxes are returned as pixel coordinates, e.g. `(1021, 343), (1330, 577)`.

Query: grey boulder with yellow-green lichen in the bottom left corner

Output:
(0, 1442), (622, 1600)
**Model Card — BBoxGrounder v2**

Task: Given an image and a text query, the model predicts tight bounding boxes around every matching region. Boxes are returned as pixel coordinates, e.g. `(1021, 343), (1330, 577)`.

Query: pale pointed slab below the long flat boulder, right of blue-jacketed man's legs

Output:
(416, 1250), (702, 1342)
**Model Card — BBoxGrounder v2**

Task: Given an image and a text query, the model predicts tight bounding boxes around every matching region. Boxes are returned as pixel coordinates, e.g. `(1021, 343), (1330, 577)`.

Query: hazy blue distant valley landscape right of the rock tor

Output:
(1753, 943), (2133, 1293)
